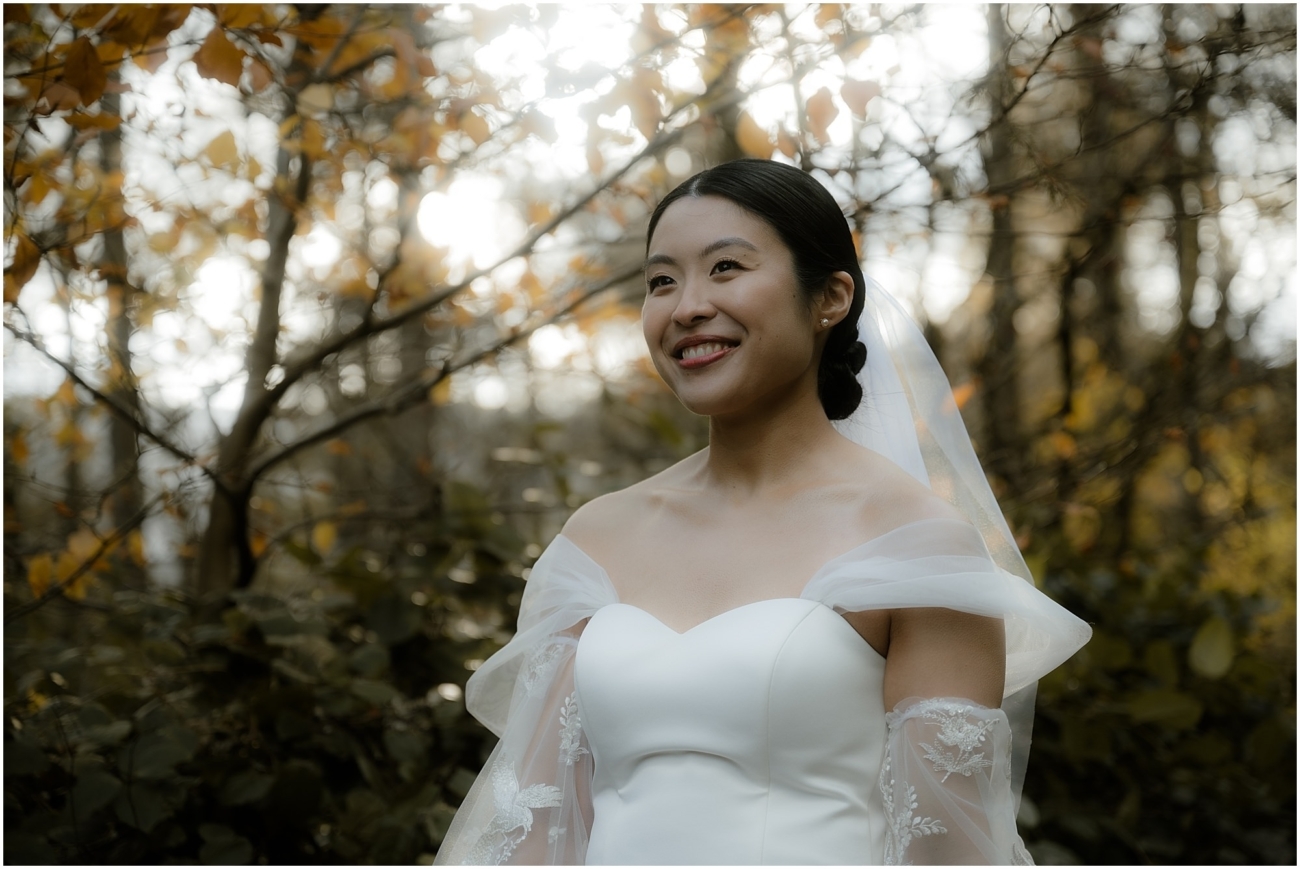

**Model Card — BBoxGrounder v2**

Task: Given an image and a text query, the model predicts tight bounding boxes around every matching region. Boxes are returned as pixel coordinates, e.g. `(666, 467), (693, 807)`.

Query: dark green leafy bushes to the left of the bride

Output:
(4, 484), (523, 865)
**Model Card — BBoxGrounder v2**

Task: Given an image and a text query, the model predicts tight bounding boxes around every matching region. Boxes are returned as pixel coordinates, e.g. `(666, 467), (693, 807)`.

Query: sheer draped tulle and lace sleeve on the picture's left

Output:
(436, 537), (618, 865)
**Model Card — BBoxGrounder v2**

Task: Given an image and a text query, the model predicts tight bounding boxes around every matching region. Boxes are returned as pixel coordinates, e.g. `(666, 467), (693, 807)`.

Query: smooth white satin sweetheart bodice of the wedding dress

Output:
(573, 598), (885, 864)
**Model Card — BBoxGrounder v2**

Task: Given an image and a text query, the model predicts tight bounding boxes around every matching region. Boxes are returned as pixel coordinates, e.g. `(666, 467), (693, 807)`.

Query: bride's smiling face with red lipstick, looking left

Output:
(641, 196), (818, 416)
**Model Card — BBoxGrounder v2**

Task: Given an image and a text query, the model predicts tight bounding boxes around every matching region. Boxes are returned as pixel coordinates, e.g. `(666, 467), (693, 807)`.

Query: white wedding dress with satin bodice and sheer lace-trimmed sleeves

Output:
(438, 519), (1088, 864)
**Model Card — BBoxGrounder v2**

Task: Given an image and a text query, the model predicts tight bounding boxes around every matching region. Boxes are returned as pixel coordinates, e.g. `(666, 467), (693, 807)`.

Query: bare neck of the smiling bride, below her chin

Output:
(705, 377), (841, 497)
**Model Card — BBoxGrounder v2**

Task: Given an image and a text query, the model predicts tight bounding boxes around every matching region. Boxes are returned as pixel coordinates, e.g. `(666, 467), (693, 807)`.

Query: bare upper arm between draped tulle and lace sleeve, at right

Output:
(884, 608), (1006, 709)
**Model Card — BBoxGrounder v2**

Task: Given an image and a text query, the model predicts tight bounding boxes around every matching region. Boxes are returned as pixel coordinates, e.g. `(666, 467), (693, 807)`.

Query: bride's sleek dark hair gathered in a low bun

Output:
(646, 159), (867, 419)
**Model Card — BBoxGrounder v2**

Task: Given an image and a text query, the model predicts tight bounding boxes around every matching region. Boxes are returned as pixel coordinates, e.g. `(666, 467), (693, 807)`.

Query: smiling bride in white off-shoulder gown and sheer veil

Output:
(438, 160), (1089, 864)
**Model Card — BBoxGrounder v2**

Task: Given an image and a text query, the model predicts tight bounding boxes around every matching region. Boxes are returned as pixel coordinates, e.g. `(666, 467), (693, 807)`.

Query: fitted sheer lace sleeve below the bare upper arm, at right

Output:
(880, 697), (1034, 865)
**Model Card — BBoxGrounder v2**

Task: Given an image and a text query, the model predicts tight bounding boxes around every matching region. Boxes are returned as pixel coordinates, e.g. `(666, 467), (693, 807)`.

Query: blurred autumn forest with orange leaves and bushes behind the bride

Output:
(4, 4), (1296, 864)
